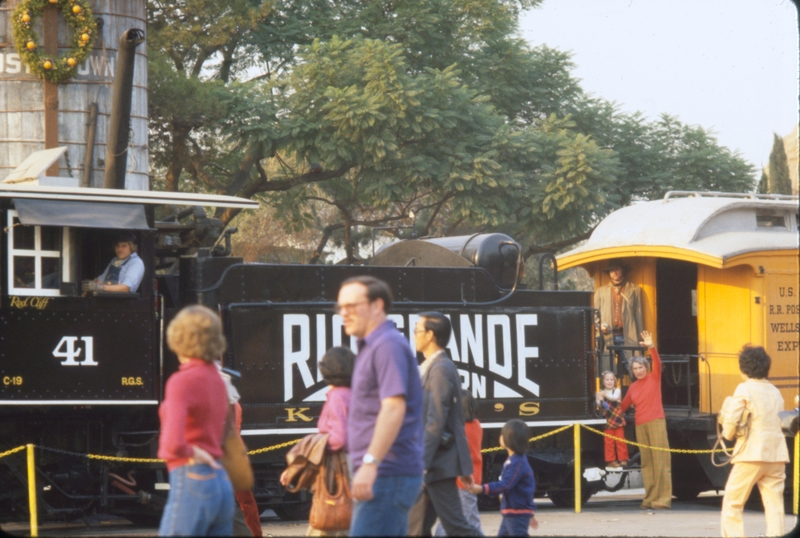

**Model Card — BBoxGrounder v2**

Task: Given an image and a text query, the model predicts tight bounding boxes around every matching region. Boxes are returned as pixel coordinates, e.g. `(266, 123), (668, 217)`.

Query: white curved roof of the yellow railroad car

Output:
(558, 193), (798, 268)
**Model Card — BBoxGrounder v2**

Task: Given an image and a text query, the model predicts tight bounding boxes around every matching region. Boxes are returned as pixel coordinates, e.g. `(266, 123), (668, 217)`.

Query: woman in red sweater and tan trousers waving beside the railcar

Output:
(620, 331), (672, 510)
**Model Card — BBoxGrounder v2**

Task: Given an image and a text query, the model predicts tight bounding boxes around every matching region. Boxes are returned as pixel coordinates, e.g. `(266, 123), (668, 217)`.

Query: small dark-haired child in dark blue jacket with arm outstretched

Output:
(470, 419), (539, 536)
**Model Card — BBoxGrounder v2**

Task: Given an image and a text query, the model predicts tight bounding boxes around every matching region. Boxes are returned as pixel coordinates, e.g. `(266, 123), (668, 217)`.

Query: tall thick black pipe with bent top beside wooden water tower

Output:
(103, 28), (144, 189)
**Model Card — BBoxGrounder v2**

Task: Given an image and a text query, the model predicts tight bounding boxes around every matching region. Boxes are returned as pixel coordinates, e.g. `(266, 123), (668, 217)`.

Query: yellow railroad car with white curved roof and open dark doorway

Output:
(558, 191), (800, 496)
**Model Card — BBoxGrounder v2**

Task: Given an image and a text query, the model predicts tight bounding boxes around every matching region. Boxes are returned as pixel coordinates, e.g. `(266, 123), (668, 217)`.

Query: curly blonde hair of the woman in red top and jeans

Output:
(167, 305), (227, 363)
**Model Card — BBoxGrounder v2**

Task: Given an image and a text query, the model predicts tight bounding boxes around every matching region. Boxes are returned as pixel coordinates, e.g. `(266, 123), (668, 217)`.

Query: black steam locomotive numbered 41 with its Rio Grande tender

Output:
(0, 184), (603, 520)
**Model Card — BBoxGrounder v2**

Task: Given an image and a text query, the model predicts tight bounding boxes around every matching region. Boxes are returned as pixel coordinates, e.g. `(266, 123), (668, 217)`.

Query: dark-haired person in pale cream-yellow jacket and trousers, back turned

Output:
(720, 346), (789, 536)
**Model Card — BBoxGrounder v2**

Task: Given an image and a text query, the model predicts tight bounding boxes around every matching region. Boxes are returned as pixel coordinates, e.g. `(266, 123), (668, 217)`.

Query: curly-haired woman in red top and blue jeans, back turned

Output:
(158, 305), (234, 536)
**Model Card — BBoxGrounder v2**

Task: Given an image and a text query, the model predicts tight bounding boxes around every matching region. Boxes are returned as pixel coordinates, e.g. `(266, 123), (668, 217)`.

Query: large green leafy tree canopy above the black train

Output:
(148, 0), (756, 261)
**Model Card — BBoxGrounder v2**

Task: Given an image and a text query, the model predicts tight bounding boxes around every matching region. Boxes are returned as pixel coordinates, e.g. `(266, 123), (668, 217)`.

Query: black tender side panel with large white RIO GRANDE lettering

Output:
(226, 304), (596, 431)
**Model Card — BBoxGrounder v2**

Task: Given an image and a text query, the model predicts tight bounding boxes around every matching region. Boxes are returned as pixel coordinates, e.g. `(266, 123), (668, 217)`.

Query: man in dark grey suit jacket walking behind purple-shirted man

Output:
(408, 312), (481, 536)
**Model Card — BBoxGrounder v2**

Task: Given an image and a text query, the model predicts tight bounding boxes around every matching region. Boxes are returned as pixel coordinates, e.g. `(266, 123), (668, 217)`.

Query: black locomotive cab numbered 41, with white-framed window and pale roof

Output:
(0, 179), (257, 518)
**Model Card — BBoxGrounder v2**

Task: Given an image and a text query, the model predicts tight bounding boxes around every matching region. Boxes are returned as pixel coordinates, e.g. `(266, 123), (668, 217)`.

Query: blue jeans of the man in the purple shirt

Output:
(350, 475), (422, 536)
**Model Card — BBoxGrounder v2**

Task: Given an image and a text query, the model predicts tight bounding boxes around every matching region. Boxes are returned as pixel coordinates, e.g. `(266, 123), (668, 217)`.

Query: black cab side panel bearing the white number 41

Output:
(0, 306), (159, 405)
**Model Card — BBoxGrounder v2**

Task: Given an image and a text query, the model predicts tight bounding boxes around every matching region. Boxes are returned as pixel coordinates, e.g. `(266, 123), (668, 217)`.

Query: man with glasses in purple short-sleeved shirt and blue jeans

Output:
(335, 276), (423, 536)
